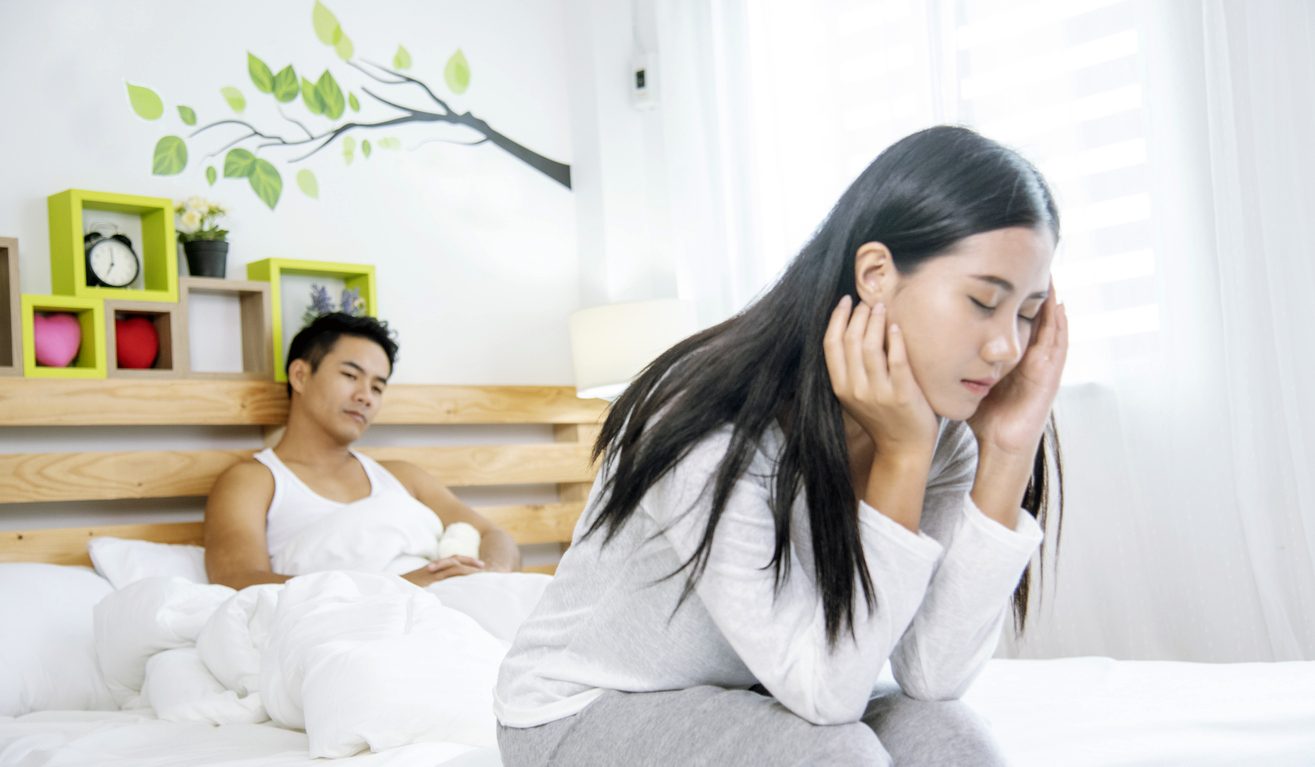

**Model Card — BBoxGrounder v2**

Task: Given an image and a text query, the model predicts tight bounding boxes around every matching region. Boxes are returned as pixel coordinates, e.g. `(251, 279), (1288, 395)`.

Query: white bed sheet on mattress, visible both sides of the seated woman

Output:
(0, 658), (1315, 767)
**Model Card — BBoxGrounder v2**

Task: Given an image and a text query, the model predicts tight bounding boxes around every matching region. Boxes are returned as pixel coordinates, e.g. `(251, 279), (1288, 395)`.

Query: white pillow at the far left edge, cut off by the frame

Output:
(0, 563), (117, 717)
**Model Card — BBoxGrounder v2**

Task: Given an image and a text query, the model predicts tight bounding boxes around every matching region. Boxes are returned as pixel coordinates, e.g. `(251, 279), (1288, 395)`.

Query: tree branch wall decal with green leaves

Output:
(128, 0), (571, 209)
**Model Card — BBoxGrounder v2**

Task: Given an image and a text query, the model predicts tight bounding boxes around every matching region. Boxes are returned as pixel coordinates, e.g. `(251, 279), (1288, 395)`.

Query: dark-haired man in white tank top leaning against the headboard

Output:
(205, 313), (521, 588)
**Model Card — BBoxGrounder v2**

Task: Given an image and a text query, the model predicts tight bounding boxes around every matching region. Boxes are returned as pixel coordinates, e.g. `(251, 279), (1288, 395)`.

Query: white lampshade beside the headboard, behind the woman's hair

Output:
(571, 299), (697, 400)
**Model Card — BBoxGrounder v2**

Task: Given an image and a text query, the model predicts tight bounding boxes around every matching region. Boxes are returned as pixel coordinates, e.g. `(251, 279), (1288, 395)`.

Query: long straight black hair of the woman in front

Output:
(585, 126), (1064, 643)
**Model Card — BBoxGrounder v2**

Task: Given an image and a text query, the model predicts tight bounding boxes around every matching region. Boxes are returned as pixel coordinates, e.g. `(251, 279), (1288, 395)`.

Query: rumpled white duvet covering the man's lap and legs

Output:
(95, 497), (548, 756)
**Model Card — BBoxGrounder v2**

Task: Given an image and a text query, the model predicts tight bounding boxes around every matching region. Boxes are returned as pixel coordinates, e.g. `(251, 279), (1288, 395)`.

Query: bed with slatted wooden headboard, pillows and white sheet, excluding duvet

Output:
(0, 379), (1315, 767)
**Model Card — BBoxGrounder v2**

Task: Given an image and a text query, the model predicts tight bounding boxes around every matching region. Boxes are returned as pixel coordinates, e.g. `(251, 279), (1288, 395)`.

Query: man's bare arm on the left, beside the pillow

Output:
(205, 460), (289, 589)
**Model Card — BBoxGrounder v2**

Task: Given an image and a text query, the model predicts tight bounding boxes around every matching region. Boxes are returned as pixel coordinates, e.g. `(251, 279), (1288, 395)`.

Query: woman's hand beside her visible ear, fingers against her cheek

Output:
(822, 296), (938, 459)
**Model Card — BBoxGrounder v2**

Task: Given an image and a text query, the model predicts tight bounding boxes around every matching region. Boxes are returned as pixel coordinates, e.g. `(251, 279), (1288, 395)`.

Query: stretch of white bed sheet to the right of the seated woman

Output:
(964, 658), (1315, 767)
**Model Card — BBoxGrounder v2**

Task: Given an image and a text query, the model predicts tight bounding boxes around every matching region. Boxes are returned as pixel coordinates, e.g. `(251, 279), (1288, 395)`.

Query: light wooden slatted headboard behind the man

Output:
(0, 378), (606, 572)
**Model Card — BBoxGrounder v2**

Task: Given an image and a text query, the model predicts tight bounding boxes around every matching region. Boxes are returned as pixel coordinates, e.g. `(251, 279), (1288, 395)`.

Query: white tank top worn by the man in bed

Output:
(252, 447), (427, 557)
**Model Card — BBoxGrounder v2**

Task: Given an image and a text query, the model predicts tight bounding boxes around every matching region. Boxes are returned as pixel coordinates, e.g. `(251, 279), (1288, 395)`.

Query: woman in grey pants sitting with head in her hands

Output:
(494, 126), (1068, 767)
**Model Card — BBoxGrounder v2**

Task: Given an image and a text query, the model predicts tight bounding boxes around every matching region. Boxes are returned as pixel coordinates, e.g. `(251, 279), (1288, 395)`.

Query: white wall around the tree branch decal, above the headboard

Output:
(0, 0), (580, 384)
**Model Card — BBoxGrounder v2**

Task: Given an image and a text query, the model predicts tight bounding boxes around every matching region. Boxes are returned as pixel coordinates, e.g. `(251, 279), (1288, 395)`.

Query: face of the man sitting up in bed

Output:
(289, 335), (392, 445)
